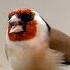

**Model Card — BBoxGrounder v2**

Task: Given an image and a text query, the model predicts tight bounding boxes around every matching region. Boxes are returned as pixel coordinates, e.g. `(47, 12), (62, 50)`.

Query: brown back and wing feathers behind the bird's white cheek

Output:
(50, 29), (70, 62)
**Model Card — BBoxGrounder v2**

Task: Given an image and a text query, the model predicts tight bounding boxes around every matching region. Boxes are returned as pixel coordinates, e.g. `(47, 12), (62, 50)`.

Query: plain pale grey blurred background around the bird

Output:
(0, 0), (70, 70)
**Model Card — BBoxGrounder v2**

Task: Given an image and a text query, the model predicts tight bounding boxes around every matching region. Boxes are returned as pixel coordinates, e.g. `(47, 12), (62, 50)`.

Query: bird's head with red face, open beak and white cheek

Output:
(7, 9), (50, 47)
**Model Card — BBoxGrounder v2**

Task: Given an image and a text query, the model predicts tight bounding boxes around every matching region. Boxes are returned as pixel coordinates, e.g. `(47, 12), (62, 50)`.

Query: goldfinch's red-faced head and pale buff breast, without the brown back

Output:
(5, 8), (63, 70)
